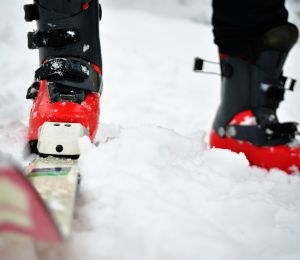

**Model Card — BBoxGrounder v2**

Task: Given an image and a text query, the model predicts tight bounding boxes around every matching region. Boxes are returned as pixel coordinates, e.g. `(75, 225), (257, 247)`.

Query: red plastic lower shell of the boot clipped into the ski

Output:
(28, 80), (100, 141)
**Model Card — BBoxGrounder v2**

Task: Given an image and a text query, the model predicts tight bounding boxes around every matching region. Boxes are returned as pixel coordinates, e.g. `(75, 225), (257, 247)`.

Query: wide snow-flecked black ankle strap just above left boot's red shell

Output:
(35, 57), (102, 92)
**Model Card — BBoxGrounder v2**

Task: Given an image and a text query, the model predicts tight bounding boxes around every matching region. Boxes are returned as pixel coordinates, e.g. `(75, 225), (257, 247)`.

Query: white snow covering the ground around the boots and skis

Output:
(0, 0), (300, 260)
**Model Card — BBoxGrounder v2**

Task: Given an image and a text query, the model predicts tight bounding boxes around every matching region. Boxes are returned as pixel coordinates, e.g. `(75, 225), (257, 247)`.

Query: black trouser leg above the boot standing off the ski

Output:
(212, 0), (288, 57)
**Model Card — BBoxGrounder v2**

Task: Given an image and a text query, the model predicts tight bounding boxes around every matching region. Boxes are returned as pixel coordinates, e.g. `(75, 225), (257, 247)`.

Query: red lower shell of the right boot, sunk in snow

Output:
(209, 131), (300, 174)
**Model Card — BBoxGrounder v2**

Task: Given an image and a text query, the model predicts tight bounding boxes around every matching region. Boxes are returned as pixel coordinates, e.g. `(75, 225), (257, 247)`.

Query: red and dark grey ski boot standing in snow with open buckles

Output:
(209, 24), (300, 174)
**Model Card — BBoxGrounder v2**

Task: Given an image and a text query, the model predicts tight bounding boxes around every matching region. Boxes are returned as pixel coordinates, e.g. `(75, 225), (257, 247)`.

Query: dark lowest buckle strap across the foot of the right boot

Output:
(226, 122), (298, 146)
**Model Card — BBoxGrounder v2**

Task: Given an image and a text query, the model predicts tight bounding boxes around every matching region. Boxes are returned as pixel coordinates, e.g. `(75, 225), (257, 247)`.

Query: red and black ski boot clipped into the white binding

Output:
(24, 0), (102, 152)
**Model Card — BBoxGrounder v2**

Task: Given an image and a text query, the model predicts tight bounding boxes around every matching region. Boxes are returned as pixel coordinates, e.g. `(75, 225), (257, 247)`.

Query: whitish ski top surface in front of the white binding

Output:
(26, 157), (79, 238)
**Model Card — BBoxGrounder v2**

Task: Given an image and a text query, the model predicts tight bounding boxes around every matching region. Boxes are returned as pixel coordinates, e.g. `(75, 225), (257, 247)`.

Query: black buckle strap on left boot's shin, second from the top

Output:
(27, 29), (79, 49)
